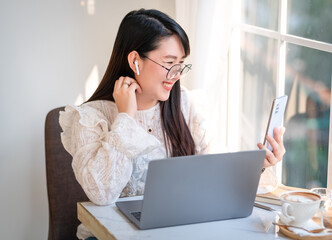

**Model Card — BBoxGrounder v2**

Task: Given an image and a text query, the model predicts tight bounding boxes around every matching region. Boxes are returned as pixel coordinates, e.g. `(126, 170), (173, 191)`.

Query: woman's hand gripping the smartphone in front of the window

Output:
(257, 127), (286, 168)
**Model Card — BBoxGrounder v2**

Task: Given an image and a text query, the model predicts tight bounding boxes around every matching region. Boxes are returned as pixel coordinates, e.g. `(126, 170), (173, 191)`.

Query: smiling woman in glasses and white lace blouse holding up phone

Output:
(60, 9), (284, 239)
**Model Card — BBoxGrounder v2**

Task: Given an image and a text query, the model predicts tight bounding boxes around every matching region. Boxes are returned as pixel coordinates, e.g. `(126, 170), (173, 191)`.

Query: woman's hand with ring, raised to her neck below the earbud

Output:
(113, 77), (142, 117)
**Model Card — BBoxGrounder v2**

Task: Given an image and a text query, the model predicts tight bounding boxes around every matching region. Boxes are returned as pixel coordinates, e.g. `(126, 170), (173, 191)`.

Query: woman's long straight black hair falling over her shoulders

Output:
(88, 9), (196, 157)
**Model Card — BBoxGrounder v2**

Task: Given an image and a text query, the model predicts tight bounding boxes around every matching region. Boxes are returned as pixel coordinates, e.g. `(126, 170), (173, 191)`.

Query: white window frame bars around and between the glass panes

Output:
(225, 0), (332, 188)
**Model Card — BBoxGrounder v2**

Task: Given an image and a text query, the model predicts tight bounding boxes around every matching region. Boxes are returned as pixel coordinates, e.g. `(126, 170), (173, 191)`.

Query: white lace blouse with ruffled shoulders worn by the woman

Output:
(59, 88), (278, 238)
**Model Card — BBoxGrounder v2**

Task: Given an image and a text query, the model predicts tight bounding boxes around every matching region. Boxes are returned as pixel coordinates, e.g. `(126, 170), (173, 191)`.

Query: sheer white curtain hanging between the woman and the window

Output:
(175, 0), (234, 152)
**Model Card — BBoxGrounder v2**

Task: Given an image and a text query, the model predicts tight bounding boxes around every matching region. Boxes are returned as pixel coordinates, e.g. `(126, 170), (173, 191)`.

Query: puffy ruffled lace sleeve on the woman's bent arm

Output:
(59, 106), (159, 205)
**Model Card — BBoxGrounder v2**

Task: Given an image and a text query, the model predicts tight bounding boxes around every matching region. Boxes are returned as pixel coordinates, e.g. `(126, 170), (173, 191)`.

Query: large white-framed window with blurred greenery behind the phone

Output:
(228, 0), (332, 188)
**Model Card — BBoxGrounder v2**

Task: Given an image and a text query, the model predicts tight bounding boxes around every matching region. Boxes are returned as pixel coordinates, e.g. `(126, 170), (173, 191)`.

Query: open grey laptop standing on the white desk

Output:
(116, 150), (265, 229)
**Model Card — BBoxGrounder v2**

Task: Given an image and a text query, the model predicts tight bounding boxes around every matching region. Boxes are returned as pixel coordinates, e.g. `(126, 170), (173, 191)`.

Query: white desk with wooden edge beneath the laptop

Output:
(77, 197), (288, 240)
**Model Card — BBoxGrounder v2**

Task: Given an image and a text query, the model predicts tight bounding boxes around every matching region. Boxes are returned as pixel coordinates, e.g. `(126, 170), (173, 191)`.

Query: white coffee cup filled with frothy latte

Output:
(279, 191), (321, 227)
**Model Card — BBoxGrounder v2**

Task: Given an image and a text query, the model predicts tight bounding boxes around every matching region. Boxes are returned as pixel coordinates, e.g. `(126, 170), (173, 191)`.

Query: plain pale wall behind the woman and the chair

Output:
(0, 0), (175, 240)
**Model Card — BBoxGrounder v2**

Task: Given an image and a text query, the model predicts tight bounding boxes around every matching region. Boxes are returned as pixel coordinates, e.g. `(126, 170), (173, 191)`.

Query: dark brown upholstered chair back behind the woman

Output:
(45, 107), (88, 240)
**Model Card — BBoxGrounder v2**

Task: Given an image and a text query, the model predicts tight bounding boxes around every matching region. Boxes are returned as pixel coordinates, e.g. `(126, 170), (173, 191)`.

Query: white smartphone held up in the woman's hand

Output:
(263, 95), (288, 151)
